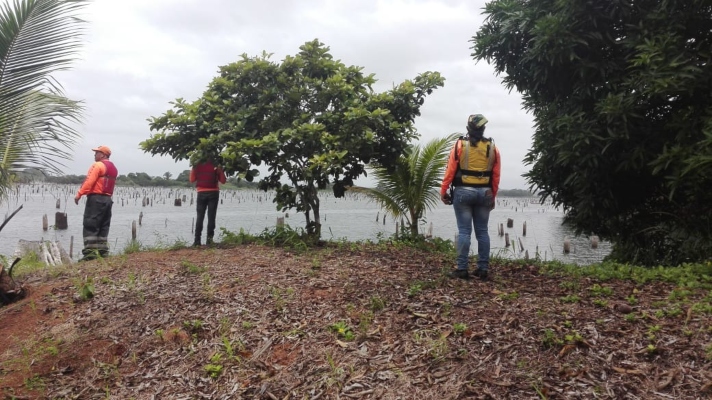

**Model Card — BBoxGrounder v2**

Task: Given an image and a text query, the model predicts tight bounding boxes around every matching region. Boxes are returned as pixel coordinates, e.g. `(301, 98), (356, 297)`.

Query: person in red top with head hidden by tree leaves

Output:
(190, 161), (227, 246)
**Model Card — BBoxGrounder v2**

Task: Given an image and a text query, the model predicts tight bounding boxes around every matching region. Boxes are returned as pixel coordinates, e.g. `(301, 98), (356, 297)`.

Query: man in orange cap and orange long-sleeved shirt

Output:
(74, 146), (119, 261)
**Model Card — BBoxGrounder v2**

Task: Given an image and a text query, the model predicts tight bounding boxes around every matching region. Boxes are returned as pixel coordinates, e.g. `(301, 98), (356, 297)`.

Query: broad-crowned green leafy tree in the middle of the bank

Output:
(141, 40), (444, 238)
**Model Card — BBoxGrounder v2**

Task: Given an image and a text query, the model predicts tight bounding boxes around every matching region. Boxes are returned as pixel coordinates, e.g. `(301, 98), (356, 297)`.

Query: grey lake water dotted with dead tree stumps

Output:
(0, 184), (610, 265)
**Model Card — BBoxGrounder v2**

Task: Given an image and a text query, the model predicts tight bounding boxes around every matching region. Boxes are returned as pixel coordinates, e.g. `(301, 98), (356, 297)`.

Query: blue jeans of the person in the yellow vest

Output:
(452, 186), (494, 271)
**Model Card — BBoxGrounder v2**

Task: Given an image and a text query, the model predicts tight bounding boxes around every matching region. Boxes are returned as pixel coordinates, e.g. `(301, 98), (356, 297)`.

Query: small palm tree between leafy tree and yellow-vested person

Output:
(349, 133), (459, 237)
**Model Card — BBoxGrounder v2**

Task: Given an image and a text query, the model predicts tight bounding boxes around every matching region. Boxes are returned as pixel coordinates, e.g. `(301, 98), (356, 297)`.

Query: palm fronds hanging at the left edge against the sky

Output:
(0, 0), (88, 200)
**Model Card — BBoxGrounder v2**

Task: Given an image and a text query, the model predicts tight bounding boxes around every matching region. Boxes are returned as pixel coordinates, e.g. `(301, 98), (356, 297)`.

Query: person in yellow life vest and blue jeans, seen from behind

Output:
(440, 114), (501, 281)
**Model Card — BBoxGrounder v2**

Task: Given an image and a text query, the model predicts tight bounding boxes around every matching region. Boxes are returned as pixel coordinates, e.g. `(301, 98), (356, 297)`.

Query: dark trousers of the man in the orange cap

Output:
(82, 194), (114, 260)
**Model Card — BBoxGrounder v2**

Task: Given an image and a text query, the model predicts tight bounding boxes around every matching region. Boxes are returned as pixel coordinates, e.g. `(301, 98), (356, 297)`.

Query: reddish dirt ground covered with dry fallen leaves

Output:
(0, 245), (712, 399)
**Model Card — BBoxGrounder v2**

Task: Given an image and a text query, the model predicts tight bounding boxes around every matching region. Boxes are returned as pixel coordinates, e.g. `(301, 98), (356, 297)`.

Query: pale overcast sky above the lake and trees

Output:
(48, 0), (533, 189)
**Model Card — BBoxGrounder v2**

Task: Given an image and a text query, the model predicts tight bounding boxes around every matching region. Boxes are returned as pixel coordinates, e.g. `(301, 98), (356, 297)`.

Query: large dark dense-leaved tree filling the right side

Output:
(473, 0), (712, 265)
